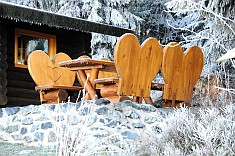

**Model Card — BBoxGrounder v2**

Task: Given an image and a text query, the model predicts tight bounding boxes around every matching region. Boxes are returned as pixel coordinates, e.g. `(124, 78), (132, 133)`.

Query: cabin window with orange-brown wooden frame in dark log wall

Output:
(15, 28), (56, 68)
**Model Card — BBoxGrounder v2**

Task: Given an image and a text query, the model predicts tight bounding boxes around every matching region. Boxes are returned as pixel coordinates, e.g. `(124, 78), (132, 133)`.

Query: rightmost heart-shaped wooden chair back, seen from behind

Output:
(162, 42), (204, 102)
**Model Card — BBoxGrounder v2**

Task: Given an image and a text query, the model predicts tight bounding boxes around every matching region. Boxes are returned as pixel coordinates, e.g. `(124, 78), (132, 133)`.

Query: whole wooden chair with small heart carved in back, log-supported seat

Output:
(28, 50), (83, 103)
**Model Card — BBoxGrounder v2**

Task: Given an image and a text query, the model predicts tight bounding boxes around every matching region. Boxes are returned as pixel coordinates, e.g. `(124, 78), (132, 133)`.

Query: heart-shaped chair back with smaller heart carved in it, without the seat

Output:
(28, 50), (75, 86)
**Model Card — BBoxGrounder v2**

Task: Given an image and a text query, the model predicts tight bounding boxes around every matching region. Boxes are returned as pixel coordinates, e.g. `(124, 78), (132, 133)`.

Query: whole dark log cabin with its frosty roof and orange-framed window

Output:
(0, 2), (133, 107)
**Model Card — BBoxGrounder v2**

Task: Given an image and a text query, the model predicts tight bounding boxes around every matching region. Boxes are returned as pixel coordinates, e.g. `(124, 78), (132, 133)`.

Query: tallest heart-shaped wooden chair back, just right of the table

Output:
(114, 33), (163, 97)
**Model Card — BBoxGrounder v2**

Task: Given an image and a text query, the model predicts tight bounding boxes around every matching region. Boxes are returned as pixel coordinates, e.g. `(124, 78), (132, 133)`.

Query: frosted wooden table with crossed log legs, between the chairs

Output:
(59, 58), (116, 99)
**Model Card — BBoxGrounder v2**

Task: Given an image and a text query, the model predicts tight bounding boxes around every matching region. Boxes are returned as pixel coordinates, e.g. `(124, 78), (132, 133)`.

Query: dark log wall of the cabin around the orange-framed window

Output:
(0, 18), (91, 107)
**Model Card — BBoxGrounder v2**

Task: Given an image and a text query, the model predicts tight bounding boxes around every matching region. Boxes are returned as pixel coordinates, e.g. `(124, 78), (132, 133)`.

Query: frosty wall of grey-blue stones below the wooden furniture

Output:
(0, 99), (169, 147)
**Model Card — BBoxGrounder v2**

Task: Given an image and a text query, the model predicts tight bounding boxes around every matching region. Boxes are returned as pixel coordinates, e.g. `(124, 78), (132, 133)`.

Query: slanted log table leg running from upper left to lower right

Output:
(78, 70), (98, 100)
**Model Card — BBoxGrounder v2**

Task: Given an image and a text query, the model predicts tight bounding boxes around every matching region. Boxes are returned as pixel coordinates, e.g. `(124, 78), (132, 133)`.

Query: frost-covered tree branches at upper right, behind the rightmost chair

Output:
(166, 0), (235, 75)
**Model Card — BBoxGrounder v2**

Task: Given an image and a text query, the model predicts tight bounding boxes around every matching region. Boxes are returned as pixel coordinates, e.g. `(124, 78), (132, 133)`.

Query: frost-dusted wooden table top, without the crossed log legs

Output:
(59, 58), (116, 72)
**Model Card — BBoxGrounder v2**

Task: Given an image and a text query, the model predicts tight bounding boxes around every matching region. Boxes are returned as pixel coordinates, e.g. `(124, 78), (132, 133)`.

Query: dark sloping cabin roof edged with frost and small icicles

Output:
(0, 1), (134, 36)
